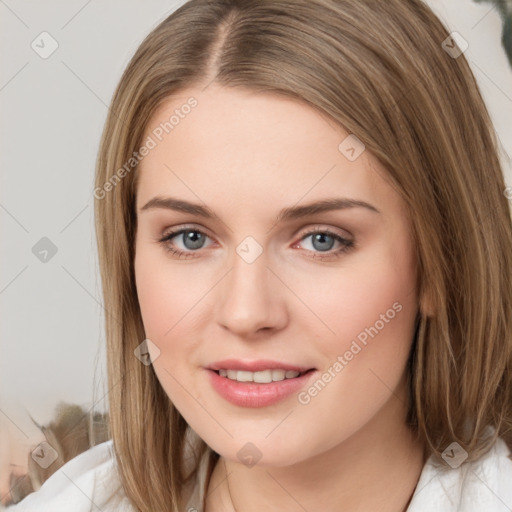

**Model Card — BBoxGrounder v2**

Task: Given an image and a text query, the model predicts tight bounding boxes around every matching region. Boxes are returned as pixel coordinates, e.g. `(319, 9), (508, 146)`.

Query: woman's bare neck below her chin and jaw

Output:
(205, 376), (426, 512)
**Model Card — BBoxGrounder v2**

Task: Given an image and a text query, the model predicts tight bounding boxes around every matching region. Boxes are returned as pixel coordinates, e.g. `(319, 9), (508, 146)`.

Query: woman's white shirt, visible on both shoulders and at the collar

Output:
(4, 438), (512, 512)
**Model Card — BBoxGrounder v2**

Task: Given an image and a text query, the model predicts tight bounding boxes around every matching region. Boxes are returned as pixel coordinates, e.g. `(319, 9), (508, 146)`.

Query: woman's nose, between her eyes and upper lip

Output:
(216, 246), (288, 338)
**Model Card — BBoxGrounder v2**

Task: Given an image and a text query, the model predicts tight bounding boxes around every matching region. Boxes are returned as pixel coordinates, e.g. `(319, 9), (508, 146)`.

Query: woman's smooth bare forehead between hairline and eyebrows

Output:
(137, 85), (399, 220)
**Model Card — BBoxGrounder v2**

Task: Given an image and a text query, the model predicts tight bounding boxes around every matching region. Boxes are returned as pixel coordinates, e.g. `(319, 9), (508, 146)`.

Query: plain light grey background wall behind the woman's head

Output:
(0, 0), (512, 441)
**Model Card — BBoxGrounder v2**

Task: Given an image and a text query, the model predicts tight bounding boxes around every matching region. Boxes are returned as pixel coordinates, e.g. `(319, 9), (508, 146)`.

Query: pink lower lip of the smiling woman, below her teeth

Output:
(207, 370), (315, 407)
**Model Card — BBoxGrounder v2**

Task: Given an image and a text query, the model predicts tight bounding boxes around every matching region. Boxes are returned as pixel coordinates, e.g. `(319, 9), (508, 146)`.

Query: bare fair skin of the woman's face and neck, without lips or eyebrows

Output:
(135, 84), (425, 512)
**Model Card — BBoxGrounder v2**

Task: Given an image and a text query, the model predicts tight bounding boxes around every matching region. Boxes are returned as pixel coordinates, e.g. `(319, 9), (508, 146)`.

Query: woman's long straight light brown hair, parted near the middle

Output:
(94, 0), (512, 512)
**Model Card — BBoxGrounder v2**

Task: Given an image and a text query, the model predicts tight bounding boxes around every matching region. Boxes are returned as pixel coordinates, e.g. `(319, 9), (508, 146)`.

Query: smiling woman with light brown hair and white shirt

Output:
(4, 0), (512, 512)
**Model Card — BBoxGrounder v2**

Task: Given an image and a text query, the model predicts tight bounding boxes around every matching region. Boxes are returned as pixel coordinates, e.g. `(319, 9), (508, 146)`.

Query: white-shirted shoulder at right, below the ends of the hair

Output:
(407, 438), (512, 512)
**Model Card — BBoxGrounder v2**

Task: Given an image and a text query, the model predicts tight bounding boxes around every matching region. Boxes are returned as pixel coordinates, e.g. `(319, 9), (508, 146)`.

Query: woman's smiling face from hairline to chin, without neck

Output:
(135, 85), (418, 466)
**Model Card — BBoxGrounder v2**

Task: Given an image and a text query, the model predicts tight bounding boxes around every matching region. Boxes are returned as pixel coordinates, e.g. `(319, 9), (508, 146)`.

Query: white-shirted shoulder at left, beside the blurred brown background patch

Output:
(0, 440), (134, 512)
